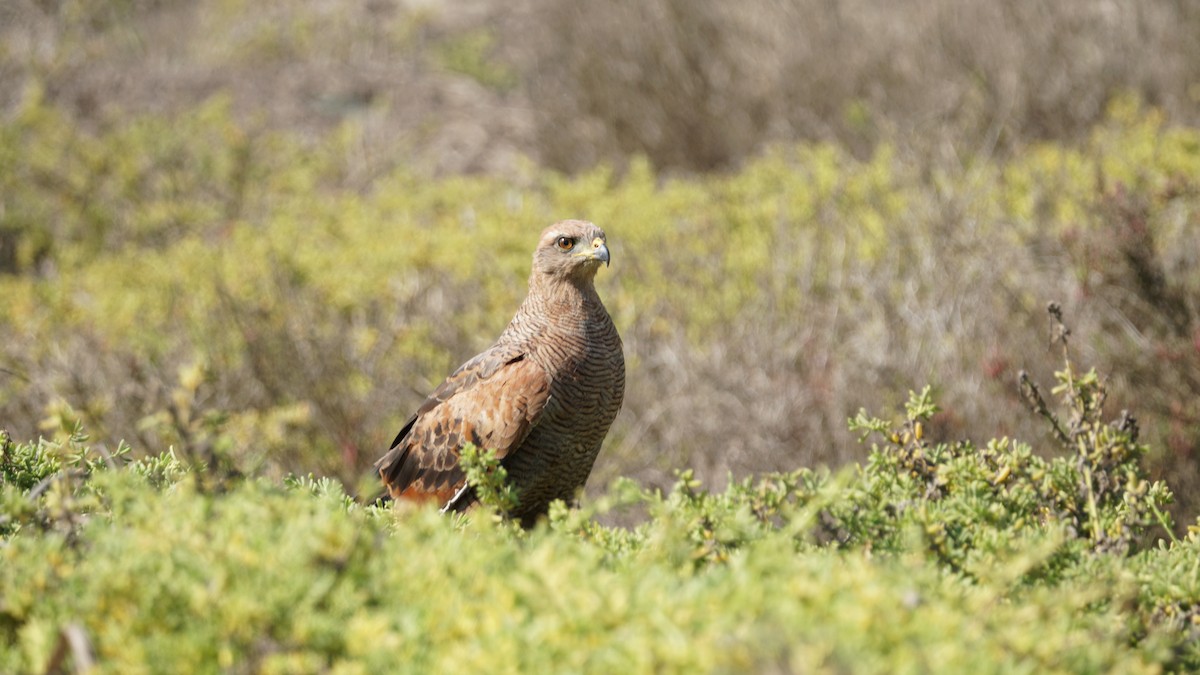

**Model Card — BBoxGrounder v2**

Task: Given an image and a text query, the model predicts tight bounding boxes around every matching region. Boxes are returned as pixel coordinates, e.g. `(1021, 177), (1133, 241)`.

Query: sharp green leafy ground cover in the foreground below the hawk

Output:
(0, 317), (1200, 673)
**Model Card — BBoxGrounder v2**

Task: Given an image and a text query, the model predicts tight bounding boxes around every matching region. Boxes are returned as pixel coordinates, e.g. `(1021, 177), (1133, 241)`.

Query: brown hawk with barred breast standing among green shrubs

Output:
(376, 220), (625, 526)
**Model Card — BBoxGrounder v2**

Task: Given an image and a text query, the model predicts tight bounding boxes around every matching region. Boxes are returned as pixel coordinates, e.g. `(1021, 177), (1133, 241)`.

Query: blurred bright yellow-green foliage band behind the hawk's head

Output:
(14, 97), (1200, 362)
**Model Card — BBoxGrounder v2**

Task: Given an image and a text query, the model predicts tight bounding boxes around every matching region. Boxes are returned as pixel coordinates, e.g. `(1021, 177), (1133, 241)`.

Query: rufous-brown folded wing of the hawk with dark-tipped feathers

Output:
(376, 347), (550, 503)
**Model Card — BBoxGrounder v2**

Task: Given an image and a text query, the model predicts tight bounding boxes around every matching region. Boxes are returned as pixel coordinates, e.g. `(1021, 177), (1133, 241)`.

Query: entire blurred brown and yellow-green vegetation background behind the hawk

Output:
(0, 0), (1200, 514)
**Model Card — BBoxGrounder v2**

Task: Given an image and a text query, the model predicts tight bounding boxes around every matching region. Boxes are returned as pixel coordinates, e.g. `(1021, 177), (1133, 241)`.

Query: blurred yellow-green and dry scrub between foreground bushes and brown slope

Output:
(0, 91), (1200, 497)
